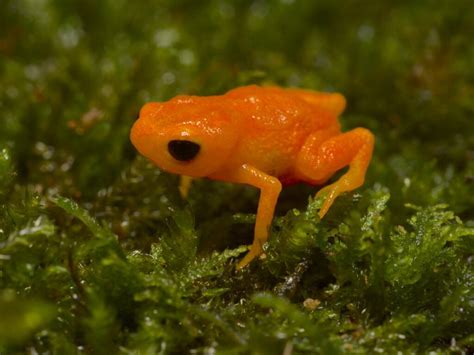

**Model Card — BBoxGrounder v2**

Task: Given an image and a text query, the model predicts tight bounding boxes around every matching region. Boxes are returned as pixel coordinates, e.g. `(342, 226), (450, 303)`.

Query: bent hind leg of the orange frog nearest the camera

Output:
(296, 128), (374, 218)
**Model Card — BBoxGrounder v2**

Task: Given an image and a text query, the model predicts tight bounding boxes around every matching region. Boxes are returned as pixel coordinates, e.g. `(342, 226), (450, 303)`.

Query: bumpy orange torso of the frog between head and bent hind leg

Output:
(216, 86), (339, 176)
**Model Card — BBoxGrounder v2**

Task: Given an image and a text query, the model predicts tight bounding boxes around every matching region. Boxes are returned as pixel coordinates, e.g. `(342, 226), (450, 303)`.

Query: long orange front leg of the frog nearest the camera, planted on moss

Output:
(231, 164), (281, 269)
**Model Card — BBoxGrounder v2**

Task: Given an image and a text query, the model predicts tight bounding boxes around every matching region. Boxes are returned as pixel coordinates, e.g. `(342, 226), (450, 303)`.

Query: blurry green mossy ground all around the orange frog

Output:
(0, 0), (474, 354)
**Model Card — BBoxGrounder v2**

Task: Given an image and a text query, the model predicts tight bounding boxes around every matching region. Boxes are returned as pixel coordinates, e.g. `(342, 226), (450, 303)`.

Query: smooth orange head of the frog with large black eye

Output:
(130, 96), (237, 177)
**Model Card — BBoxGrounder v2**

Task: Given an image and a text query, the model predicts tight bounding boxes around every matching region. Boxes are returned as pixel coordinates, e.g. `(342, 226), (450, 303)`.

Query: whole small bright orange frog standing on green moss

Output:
(130, 85), (374, 268)
